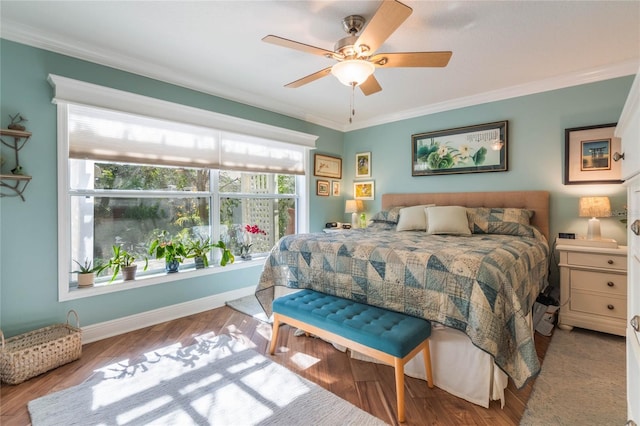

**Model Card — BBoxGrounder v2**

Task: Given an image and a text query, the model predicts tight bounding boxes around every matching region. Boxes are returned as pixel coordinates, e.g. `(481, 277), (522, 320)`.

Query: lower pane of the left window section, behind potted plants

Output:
(71, 196), (210, 271)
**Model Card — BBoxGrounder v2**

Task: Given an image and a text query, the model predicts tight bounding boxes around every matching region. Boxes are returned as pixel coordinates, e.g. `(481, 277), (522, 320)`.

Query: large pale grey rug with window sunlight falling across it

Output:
(28, 335), (385, 426)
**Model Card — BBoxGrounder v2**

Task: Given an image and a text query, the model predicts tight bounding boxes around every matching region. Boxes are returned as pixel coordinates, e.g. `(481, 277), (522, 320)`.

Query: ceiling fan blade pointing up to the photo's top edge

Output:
(355, 0), (413, 55)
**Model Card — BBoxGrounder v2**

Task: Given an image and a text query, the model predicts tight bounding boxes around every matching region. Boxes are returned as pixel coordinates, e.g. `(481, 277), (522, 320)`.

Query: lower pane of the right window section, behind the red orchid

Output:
(220, 197), (296, 255)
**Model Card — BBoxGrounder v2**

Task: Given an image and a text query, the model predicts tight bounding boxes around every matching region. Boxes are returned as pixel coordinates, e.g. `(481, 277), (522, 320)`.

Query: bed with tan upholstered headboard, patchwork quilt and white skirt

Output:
(256, 191), (549, 407)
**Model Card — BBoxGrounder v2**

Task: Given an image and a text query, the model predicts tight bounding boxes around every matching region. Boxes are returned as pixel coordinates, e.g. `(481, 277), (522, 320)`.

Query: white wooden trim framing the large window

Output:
(48, 74), (318, 302)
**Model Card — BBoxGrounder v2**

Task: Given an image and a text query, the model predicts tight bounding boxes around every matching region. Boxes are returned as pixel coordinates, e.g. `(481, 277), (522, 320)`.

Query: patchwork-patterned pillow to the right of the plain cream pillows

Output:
(467, 207), (534, 237)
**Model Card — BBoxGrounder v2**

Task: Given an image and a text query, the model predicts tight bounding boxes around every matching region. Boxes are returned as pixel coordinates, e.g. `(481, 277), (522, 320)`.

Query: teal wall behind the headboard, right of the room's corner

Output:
(344, 76), (633, 244)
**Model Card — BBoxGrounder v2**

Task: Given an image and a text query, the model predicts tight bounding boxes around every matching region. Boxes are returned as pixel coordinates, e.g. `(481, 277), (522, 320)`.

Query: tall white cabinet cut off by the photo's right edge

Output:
(615, 70), (640, 425)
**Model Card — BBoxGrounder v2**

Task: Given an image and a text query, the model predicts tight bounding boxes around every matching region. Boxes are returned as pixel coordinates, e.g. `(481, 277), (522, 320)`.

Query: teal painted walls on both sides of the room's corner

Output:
(0, 40), (632, 336)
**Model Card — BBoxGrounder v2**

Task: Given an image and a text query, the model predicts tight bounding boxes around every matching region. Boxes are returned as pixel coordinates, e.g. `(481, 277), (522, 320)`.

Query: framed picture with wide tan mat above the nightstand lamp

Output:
(564, 123), (622, 185)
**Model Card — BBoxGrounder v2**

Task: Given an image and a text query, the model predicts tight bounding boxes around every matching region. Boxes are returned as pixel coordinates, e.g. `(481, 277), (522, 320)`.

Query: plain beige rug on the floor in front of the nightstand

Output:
(520, 328), (627, 426)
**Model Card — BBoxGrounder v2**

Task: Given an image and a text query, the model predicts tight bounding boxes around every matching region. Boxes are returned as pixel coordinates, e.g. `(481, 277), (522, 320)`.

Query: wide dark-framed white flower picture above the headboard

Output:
(411, 120), (507, 176)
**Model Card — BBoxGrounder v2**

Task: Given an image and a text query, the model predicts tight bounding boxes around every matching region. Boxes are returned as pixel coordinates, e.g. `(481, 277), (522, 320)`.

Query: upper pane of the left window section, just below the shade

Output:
(69, 159), (209, 191)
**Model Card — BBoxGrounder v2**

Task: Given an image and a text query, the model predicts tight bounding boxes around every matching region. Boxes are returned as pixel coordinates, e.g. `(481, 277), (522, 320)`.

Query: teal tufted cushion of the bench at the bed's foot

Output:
(273, 290), (431, 358)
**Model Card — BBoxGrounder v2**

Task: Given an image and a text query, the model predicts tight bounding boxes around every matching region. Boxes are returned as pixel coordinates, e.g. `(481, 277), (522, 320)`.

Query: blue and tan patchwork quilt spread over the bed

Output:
(256, 228), (549, 388)
